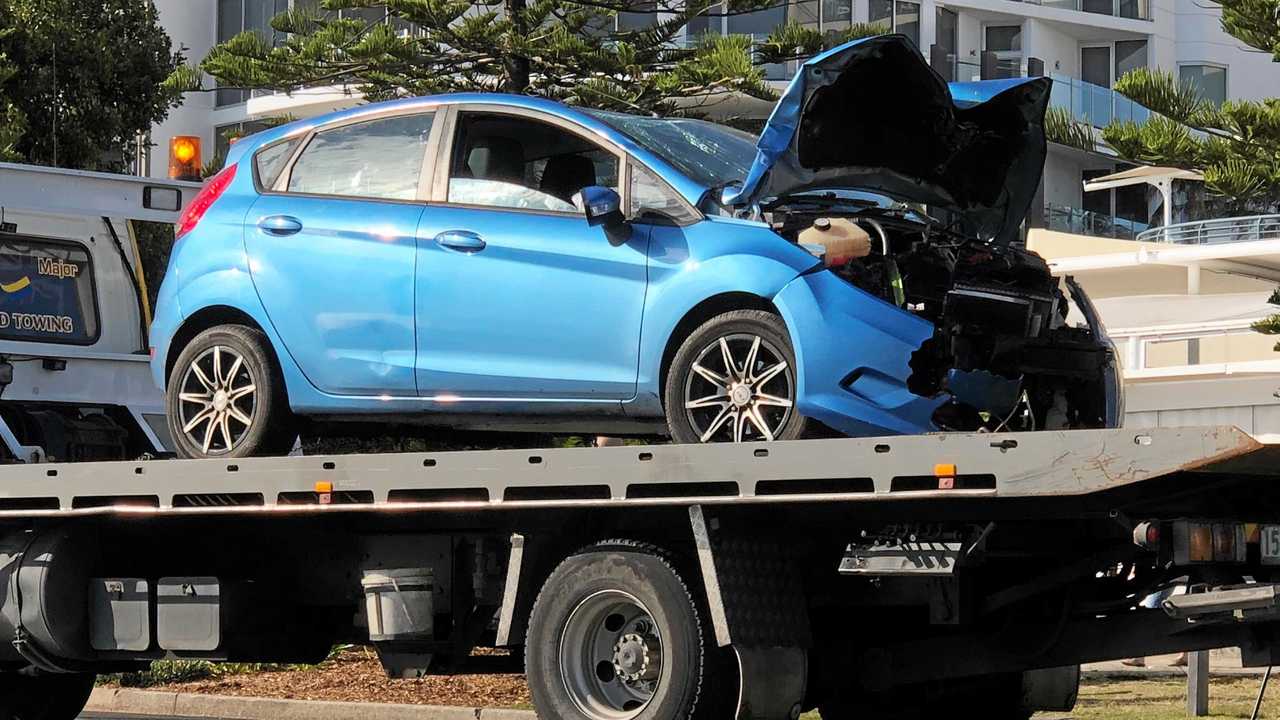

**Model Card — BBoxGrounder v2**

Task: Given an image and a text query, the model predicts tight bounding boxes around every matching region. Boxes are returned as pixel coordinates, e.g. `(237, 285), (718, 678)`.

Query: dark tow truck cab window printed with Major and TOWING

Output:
(0, 237), (97, 345)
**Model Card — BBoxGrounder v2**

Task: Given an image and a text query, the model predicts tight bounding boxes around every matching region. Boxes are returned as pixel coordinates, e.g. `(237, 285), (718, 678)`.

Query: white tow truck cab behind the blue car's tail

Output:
(0, 163), (200, 462)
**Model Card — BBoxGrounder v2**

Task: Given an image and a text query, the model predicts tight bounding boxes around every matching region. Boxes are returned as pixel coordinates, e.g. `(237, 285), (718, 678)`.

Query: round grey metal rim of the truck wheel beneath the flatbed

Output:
(559, 591), (666, 720)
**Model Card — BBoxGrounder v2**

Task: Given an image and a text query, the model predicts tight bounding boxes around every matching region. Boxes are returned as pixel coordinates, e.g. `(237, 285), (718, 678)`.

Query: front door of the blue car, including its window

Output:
(417, 106), (648, 411)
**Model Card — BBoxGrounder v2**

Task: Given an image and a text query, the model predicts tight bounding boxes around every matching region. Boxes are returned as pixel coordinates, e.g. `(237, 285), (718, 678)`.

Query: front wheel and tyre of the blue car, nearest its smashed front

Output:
(663, 310), (808, 443)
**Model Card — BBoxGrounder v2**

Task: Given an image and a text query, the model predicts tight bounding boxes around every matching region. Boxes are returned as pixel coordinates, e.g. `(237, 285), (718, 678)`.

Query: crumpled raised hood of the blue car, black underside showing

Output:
(722, 35), (1052, 242)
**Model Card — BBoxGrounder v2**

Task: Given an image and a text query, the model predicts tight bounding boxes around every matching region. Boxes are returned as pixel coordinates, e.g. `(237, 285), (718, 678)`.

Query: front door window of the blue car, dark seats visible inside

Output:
(448, 113), (618, 213)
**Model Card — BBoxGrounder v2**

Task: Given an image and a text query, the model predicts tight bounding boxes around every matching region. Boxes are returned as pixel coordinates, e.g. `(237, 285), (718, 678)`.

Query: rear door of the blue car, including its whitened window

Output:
(244, 111), (434, 397)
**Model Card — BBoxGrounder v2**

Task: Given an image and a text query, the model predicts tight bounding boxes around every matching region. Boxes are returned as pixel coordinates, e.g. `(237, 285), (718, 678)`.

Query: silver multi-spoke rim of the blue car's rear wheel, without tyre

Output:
(178, 345), (257, 455)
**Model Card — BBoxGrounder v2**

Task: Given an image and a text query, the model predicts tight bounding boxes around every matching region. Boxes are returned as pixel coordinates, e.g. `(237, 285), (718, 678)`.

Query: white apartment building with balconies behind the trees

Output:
(147, 0), (1280, 238)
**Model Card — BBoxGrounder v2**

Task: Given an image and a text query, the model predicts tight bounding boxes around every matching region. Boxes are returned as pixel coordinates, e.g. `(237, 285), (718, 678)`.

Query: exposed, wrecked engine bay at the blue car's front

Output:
(772, 199), (1119, 432)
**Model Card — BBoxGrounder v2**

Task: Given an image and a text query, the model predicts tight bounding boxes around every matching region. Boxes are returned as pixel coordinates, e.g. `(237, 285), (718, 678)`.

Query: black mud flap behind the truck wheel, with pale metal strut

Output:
(689, 505), (810, 720)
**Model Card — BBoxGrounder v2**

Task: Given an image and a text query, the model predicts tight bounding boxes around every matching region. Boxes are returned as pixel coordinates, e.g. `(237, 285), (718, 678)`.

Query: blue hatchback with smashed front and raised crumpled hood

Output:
(151, 36), (1120, 456)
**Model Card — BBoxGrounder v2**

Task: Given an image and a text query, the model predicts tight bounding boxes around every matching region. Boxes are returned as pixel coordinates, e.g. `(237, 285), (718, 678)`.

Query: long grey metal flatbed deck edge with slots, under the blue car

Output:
(0, 427), (1264, 518)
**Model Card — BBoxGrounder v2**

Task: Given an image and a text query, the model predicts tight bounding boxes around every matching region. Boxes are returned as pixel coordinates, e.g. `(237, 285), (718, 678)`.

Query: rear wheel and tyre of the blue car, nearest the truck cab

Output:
(165, 325), (297, 457)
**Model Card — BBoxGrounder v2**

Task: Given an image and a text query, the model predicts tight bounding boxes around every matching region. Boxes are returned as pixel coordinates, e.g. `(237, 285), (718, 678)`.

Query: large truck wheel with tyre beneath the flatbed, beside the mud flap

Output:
(525, 541), (736, 720)
